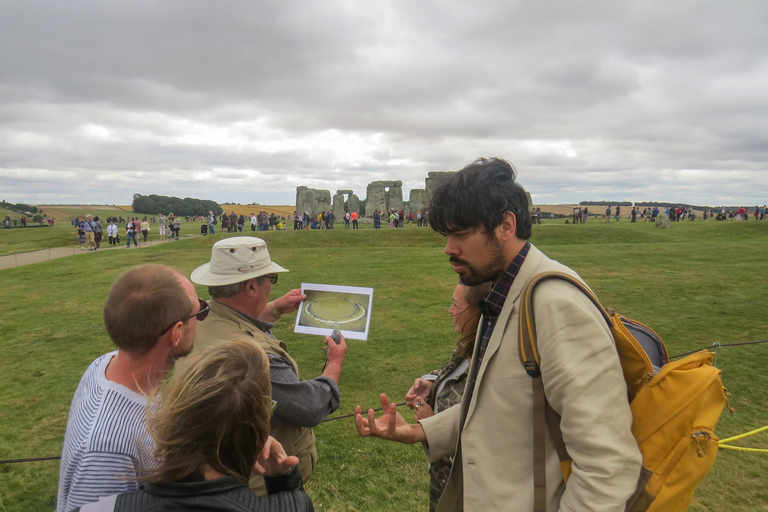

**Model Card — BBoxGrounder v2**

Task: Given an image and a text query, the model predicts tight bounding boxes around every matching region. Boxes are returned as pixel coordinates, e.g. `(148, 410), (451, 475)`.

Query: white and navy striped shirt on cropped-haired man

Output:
(56, 352), (152, 512)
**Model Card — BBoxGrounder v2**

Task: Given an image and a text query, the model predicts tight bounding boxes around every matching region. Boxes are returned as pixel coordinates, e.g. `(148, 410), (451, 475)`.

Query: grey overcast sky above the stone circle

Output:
(0, 0), (768, 205)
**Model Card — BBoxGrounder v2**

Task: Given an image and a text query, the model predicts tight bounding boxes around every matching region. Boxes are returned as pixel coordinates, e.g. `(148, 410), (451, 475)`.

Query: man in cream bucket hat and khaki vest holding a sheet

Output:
(184, 236), (347, 496)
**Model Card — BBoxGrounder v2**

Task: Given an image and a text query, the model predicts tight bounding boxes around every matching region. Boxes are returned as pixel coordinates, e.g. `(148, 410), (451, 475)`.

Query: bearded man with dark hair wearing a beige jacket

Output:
(355, 158), (641, 512)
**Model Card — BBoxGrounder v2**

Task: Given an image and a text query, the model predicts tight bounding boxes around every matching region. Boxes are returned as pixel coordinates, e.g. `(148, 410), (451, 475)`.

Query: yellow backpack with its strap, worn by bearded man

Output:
(519, 272), (727, 512)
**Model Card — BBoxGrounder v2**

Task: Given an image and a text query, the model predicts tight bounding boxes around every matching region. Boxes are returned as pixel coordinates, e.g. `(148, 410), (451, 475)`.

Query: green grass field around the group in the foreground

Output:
(0, 220), (768, 512)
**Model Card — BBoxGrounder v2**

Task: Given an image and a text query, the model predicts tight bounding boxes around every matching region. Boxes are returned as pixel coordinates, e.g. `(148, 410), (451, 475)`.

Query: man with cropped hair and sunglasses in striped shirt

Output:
(56, 265), (208, 512)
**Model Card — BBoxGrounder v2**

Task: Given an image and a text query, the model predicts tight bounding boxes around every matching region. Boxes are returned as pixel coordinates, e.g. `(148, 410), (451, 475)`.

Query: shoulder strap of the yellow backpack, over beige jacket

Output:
(518, 272), (613, 512)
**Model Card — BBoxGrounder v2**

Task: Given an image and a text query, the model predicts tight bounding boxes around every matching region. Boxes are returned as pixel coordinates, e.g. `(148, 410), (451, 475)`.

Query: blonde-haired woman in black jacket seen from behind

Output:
(80, 340), (314, 512)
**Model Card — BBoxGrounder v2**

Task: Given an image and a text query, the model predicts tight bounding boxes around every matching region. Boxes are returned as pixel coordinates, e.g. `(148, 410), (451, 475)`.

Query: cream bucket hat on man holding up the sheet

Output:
(190, 236), (288, 286)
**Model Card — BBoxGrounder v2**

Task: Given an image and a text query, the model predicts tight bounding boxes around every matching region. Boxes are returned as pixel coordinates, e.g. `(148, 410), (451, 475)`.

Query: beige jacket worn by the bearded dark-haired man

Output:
(421, 247), (641, 512)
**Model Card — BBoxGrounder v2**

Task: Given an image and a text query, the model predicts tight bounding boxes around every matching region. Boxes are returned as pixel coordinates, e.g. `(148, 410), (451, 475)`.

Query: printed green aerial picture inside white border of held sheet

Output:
(299, 290), (369, 332)
